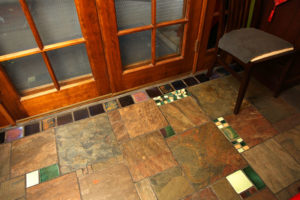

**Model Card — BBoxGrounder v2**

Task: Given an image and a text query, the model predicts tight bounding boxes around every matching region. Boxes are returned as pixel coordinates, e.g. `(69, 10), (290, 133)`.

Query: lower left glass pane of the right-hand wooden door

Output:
(119, 30), (151, 66)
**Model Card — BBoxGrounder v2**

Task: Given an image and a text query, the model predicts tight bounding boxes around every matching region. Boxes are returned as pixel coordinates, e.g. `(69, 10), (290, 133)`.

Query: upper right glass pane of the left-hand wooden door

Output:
(27, 0), (82, 45)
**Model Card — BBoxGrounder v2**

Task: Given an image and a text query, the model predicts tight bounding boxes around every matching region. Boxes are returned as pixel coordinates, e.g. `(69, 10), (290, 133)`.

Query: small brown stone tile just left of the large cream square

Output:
(211, 178), (241, 200)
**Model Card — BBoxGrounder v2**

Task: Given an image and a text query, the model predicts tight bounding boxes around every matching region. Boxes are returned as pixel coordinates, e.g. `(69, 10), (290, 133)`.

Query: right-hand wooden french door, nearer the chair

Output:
(96, 0), (203, 92)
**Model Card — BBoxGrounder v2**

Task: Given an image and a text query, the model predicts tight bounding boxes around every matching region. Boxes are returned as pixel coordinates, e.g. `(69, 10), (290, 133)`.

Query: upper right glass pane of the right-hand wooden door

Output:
(156, 0), (185, 23)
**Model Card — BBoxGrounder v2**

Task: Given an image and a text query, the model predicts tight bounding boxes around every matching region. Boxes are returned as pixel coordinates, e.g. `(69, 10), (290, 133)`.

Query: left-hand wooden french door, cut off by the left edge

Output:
(0, 0), (111, 125)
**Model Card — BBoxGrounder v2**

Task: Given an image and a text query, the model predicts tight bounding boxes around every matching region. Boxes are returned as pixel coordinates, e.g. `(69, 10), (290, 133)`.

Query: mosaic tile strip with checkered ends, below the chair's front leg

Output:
(214, 117), (249, 153)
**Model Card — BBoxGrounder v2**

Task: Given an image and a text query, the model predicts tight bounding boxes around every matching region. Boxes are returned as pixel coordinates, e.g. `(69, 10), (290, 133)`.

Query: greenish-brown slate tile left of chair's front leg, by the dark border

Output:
(188, 76), (250, 119)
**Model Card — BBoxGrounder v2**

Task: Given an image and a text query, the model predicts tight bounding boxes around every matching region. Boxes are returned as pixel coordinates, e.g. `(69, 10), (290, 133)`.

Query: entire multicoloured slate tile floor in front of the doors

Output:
(0, 70), (300, 200)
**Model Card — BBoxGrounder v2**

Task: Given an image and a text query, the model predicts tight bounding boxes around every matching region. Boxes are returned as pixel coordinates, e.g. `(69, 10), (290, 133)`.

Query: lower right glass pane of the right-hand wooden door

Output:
(156, 24), (184, 58)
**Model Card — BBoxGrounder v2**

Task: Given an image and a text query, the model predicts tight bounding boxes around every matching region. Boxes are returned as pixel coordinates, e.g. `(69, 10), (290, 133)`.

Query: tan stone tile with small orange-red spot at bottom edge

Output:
(79, 165), (139, 200)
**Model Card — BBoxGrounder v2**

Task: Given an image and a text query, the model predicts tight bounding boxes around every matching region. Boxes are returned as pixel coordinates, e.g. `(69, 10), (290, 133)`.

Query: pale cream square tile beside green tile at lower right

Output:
(226, 170), (253, 194)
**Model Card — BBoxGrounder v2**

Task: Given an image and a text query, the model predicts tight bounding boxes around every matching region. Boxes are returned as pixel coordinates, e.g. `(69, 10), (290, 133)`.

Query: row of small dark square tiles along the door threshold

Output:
(0, 67), (236, 144)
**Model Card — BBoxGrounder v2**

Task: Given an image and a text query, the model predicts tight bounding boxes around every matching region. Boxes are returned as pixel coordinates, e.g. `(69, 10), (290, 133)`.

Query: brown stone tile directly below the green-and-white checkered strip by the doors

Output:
(159, 96), (209, 133)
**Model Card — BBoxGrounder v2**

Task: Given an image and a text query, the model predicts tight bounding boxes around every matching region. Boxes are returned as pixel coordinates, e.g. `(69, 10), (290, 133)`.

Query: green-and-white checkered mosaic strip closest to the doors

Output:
(153, 89), (191, 106)
